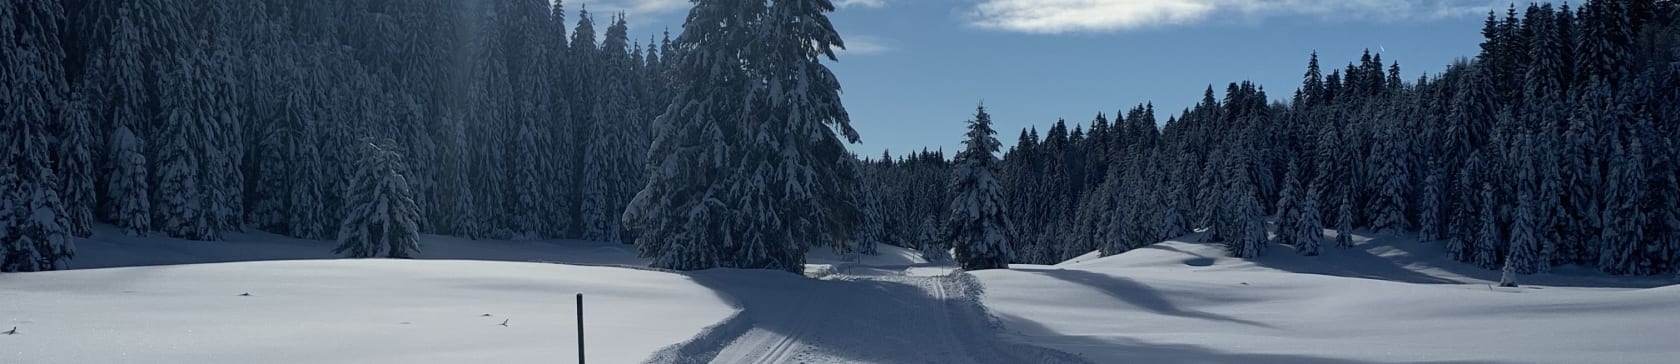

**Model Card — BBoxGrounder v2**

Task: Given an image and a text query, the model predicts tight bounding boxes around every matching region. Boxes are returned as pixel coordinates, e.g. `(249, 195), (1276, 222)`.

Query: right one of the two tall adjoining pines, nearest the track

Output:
(729, 0), (858, 272)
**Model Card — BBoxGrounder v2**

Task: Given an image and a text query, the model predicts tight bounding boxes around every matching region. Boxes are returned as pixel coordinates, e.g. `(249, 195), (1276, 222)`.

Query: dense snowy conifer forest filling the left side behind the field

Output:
(0, 0), (674, 272)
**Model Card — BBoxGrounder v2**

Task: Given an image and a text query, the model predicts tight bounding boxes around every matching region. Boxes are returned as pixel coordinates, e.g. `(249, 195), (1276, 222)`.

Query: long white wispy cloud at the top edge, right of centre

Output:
(968, 0), (1497, 34)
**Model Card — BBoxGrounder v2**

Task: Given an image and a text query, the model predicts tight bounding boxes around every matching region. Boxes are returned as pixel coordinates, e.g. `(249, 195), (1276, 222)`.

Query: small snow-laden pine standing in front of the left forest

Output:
(333, 141), (420, 258)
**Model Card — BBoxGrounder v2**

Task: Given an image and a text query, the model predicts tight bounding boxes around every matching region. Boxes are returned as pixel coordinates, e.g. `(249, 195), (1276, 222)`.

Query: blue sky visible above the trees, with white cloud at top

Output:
(594, 0), (1509, 156)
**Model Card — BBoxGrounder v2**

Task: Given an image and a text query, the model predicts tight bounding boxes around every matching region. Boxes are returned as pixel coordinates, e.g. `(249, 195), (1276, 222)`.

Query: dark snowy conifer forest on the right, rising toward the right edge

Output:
(865, 0), (1680, 275)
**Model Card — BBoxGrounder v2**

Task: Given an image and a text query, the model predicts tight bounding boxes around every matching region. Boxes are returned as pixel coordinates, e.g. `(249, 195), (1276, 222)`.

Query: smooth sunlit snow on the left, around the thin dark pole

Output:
(0, 260), (734, 364)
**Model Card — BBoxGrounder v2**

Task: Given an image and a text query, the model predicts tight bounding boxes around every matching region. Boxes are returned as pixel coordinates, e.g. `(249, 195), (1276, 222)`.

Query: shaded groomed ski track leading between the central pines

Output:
(647, 266), (1089, 364)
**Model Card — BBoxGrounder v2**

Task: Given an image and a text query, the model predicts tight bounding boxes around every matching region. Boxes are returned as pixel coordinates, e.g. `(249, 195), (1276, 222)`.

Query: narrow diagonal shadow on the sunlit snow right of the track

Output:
(1033, 270), (1277, 329)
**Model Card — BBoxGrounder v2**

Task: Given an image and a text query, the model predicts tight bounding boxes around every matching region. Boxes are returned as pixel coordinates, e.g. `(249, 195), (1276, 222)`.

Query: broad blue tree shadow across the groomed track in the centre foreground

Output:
(647, 270), (1077, 364)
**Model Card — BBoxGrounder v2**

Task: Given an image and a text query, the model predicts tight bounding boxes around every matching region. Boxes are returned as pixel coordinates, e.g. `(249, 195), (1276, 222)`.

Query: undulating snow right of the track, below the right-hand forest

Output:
(973, 237), (1680, 362)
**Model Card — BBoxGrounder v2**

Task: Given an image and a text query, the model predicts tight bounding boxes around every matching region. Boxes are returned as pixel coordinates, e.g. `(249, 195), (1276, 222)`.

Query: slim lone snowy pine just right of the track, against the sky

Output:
(944, 106), (1015, 270)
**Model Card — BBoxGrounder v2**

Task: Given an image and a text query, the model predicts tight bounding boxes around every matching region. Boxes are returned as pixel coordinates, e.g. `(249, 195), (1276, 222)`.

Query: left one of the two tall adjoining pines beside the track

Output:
(624, 0), (764, 270)
